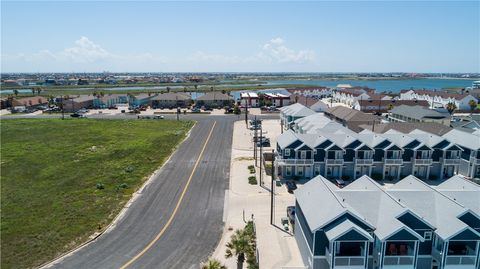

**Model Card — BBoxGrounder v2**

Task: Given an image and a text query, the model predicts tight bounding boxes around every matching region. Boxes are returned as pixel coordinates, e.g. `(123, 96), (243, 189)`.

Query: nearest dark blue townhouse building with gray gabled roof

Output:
(294, 176), (480, 269)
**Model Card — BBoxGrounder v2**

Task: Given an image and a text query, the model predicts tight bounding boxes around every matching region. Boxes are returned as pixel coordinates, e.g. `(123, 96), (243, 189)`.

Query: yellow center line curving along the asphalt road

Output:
(120, 121), (217, 269)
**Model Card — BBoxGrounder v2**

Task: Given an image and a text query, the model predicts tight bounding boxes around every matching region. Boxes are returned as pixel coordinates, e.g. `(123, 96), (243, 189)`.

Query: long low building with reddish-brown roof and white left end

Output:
(353, 99), (429, 113)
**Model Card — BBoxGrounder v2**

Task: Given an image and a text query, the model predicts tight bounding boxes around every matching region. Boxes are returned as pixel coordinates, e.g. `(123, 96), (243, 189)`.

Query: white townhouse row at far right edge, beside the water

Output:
(400, 90), (478, 111)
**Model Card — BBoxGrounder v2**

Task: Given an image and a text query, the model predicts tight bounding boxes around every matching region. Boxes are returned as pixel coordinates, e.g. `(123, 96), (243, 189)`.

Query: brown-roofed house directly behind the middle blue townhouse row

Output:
(325, 106), (381, 132)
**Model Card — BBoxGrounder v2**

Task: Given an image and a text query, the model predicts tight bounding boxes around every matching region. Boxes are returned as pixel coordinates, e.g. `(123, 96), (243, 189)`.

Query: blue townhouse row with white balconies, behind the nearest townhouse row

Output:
(275, 115), (470, 180)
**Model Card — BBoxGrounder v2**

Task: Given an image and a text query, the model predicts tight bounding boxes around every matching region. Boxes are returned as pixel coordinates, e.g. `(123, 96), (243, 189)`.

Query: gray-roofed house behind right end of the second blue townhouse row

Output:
(388, 105), (451, 126)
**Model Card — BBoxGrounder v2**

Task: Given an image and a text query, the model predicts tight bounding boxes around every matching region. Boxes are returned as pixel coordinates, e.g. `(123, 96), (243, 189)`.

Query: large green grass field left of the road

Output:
(0, 119), (193, 269)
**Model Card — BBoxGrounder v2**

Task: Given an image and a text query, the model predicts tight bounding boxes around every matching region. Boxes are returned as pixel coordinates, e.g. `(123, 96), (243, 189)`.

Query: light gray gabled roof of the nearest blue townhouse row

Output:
(295, 176), (480, 241)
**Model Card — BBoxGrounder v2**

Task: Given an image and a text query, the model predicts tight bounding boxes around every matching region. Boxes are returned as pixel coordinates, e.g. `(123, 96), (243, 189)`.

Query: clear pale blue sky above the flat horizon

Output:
(1, 1), (480, 72)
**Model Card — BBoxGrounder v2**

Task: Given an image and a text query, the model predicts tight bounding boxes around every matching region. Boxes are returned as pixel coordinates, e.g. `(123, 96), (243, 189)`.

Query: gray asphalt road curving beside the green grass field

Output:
(37, 115), (278, 269)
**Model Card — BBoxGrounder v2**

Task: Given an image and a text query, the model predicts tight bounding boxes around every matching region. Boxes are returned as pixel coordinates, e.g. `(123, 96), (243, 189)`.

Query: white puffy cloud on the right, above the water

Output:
(263, 37), (316, 63)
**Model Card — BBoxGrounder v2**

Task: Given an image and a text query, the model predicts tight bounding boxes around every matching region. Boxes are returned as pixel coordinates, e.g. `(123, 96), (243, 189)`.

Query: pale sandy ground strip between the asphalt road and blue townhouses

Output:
(212, 120), (304, 268)
